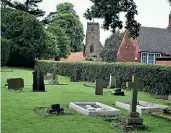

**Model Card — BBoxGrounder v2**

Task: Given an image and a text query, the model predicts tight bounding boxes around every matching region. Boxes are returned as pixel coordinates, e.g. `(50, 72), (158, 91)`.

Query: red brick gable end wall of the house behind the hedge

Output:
(117, 32), (141, 62)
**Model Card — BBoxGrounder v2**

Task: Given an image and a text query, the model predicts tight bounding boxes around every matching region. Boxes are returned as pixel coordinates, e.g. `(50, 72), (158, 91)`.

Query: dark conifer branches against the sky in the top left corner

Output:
(2, 0), (45, 17)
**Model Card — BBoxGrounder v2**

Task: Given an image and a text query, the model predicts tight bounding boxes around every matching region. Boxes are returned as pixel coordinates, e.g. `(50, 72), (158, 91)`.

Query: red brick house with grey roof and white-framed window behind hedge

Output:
(117, 14), (171, 64)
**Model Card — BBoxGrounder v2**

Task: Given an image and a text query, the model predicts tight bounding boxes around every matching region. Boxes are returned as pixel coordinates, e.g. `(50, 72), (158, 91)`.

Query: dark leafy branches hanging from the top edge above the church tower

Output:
(84, 0), (140, 38)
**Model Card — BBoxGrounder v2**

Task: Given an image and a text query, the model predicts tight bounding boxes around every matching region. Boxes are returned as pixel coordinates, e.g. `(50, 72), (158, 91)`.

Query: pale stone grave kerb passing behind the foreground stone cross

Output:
(115, 101), (168, 114)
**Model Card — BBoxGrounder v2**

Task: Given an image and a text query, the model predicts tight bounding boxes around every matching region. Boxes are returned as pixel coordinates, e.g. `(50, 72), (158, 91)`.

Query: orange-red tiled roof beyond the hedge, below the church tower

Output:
(60, 52), (85, 62)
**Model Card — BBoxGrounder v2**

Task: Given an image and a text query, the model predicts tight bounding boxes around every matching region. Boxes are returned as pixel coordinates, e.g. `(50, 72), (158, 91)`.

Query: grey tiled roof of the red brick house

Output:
(137, 27), (171, 54)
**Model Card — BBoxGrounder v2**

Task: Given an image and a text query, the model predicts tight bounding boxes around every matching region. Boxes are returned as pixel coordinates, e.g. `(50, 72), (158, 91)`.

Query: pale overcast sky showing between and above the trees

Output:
(39, 0), (171, 44)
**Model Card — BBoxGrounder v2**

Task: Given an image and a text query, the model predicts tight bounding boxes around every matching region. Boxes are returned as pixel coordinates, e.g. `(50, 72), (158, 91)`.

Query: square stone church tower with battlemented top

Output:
(84, 22), (102, 58)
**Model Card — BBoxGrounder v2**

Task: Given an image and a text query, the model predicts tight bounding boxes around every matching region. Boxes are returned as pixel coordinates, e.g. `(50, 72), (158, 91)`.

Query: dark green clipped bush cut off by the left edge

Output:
(1, 37), (10, 66)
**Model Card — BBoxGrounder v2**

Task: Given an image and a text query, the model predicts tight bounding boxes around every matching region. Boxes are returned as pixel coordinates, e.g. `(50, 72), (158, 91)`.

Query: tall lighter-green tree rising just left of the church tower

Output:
(47, 2), (84, 52)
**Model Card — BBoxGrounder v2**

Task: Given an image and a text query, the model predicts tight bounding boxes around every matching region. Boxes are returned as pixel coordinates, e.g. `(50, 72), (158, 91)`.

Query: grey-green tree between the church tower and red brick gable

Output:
(100, 31), (123, 62)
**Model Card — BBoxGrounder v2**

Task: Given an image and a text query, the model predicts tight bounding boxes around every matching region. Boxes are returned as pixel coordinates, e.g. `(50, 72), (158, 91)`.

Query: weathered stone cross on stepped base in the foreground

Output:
(126, 76), (144, 129)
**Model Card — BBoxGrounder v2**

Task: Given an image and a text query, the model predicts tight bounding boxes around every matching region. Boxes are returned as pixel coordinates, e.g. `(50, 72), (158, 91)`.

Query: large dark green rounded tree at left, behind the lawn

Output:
(1, 8), (46, 67)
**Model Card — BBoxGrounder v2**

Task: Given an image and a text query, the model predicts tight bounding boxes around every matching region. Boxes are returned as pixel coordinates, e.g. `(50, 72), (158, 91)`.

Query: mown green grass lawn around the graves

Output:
(1, 68), (171, 133)
